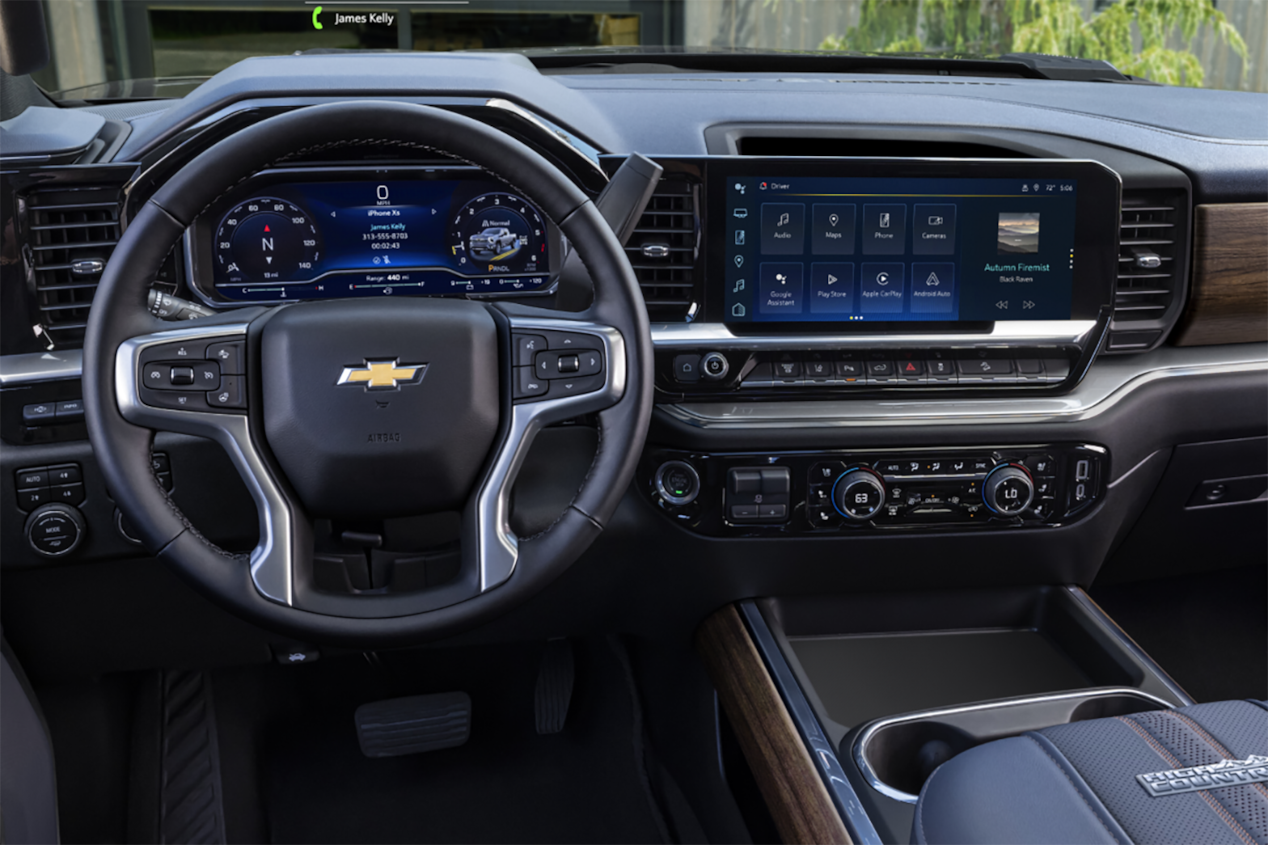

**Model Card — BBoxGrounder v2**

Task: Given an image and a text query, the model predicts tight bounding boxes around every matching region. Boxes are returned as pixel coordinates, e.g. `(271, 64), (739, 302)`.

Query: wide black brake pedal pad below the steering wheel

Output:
(356, 693), (472, 757)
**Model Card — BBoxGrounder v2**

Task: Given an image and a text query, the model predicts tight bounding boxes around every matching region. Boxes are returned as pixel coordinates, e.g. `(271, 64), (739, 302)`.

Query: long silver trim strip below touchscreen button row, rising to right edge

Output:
(658, 344), (1268, 430)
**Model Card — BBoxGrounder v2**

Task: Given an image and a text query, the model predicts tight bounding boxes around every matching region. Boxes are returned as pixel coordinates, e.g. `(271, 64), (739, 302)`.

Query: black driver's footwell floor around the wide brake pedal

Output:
(254, 639), (670, 845)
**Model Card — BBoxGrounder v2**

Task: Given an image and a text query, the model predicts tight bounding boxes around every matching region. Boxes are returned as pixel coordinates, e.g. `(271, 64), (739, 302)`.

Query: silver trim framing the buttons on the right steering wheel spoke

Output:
(473, 317), (626, 593)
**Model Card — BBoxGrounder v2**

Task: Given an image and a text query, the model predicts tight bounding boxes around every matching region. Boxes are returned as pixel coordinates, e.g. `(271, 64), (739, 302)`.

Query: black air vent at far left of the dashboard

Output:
(25, 187), (119, 349)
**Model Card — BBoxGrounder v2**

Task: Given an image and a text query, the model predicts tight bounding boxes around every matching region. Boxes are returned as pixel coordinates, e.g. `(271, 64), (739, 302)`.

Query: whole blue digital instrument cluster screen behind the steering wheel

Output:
(188, 167), (559, 302)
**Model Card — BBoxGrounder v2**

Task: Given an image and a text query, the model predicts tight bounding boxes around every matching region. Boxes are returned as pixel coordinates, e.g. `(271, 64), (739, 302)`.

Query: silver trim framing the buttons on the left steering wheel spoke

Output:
(114, 322), (295, 605)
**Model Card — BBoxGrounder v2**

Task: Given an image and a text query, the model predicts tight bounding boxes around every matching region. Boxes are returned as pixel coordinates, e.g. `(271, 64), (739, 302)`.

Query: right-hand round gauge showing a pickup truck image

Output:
(449, 192), (548, 275)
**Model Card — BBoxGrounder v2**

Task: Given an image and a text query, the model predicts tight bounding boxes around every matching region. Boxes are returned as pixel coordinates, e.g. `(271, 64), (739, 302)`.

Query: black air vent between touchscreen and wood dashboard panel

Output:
(1110, 190), (1187, 351)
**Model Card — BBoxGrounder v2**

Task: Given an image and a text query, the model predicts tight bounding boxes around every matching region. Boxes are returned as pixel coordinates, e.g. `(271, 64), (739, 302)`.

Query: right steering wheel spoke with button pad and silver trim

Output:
(464, 310), (626, 593)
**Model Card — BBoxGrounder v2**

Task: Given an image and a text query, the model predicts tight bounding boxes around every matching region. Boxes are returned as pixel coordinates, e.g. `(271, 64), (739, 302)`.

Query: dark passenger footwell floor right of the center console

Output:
(1092, 567), (1268, 702)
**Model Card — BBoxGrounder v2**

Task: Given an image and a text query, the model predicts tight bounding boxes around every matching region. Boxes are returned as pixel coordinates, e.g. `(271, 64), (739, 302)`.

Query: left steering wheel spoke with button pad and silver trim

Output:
(114, 324), (301, 605)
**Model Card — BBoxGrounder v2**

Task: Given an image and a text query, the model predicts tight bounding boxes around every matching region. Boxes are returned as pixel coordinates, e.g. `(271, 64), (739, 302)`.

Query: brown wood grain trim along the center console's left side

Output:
(696, 605), (852, 845)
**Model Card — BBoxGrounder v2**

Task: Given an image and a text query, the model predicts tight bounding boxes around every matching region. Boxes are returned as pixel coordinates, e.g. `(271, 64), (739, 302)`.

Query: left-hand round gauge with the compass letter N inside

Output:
(214, 197), (321, 284)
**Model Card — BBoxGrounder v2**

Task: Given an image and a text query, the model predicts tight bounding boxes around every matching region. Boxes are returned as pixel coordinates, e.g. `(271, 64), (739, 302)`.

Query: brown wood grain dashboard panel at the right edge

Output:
(1175, 203), (1268, 346)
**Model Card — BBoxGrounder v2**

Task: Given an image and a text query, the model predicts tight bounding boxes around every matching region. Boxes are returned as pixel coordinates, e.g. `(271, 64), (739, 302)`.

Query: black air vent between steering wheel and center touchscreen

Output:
(625, 179), (700, 322)
